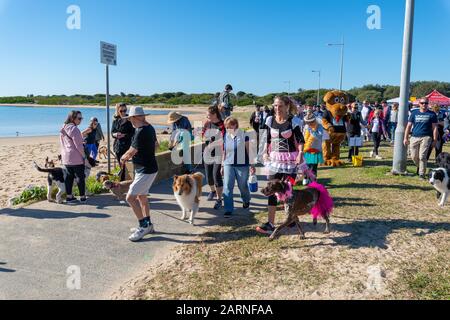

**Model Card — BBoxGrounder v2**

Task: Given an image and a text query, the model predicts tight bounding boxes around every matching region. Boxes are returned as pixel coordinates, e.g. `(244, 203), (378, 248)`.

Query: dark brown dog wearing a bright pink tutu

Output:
(261, 180), (333, 240)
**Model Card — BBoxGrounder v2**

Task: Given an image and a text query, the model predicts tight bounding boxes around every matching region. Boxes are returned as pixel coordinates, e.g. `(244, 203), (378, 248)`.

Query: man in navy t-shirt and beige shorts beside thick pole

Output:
(404, 99), (438, 179)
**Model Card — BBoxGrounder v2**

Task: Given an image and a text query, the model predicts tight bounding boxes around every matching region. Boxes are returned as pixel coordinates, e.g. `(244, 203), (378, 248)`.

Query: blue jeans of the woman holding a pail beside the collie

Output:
(223, 165), (251, 213)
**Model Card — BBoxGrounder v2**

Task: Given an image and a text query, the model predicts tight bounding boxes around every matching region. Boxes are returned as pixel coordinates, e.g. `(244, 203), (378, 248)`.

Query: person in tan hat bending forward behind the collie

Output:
(167, 112), (193, 174)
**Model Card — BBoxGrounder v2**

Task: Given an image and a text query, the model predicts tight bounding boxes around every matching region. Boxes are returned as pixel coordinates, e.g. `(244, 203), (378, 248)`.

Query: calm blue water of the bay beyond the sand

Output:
(0, 106), (170, 137)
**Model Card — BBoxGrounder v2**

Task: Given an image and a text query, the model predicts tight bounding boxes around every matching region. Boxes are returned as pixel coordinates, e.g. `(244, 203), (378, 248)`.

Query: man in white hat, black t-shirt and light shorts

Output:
(120, 107), (158, 242)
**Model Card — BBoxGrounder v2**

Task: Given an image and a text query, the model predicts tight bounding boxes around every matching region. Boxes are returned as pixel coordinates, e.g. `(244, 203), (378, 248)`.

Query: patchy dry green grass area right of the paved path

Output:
(126, 145), (450, 299)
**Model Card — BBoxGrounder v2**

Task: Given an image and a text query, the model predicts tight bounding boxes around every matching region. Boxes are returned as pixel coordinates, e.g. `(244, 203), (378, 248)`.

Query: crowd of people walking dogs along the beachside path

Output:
(56, 85), (449, 241)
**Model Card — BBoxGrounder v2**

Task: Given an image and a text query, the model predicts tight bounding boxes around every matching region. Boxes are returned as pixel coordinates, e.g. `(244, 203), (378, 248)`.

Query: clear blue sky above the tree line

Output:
(0, 0), (450, 96)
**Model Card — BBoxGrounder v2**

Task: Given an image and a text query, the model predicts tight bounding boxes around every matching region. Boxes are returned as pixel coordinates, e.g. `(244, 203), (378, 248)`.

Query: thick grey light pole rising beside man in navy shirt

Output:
(392, 0), (414, 174)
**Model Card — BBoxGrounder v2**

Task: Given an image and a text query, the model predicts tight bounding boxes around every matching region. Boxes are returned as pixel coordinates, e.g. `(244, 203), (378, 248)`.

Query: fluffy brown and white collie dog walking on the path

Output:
(173, 173), (205, 225)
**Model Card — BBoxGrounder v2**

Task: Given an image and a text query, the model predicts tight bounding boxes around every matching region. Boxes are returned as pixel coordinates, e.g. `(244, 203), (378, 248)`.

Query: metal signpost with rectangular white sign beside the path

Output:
(100, 42), (120, 174)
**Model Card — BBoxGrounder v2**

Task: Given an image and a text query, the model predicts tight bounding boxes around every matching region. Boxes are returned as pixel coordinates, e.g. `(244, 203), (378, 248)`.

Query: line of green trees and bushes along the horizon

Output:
(0, 81), (450, 106)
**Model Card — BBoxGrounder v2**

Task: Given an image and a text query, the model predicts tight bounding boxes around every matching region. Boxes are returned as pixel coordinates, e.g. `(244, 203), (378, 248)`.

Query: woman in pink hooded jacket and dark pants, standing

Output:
(60, 111), (86, 204)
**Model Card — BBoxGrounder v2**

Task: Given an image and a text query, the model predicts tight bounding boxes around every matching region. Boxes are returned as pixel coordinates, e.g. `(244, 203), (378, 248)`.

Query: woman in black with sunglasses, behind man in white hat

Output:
(111, 103), (135, 168)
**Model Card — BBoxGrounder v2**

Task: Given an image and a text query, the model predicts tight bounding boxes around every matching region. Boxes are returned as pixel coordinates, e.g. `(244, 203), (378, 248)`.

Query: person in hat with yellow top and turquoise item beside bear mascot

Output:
(304, 112), (324, 183)
